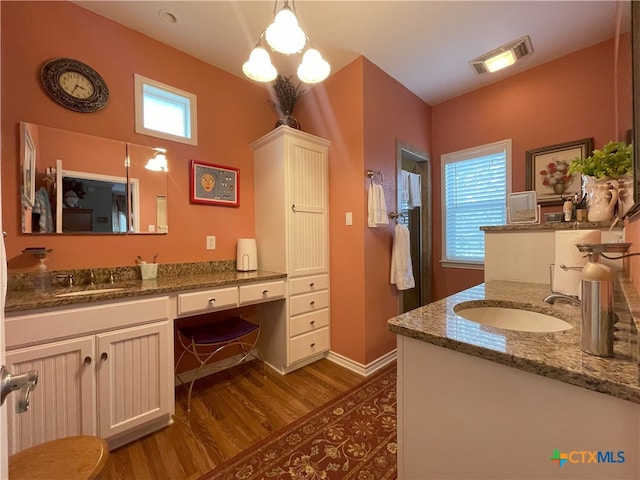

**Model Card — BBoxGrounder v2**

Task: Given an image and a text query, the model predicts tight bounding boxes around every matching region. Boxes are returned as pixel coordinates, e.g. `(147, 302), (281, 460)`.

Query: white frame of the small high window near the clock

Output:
(134, 73), (198, 146)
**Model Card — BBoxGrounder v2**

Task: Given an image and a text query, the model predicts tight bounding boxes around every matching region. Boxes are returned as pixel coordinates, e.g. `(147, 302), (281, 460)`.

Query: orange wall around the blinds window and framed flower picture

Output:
(431, 35), (632, 299)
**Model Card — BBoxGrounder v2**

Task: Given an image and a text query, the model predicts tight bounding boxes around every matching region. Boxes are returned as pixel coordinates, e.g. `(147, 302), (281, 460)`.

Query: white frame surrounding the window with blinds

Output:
(440, 138), (512, 270)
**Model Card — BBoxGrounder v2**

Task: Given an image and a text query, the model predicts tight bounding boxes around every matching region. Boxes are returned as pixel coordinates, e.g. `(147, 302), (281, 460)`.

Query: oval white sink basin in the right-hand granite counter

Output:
(453, 303), (573, 332)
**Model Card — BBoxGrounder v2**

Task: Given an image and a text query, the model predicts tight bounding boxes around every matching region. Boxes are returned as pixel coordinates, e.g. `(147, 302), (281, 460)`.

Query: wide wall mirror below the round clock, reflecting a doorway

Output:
(20, 122), (168, 234)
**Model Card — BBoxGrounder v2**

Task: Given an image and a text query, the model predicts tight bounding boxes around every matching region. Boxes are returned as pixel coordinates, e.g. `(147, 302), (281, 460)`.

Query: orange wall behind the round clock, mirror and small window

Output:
(0, 2), (276, 271)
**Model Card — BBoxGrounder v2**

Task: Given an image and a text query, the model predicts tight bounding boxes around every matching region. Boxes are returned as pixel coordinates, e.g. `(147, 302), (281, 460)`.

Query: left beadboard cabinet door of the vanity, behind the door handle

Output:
(7, 336), (96, 455)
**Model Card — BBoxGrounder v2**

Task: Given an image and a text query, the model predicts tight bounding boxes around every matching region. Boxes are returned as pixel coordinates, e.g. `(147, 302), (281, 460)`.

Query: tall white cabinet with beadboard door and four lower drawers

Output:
(251, 126), (330, 373)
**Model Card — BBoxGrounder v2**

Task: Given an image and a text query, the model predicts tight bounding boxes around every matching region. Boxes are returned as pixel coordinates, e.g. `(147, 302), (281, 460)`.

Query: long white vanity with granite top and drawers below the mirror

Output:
(5, 270), (286, 454)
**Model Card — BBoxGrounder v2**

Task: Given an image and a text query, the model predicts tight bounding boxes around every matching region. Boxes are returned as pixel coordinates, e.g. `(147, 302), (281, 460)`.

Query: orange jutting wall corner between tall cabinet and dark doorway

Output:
(296, 57), (430, 365)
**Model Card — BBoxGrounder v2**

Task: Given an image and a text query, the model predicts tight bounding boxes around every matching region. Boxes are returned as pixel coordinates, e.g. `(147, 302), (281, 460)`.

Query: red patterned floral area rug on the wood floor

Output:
(199, 363), (397, 480)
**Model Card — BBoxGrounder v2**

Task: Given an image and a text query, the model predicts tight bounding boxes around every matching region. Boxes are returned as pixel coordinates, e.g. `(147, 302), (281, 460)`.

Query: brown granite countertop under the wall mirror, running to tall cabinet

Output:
(5, 270), (287, 314)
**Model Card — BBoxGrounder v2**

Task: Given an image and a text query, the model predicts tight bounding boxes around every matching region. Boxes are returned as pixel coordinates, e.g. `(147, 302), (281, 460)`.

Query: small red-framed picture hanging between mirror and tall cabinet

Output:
(189, 160), (240, 207)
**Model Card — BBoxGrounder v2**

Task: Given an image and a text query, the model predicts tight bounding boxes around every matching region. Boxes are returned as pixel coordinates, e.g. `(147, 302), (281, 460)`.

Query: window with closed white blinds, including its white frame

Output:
(441, 139), (511, 268)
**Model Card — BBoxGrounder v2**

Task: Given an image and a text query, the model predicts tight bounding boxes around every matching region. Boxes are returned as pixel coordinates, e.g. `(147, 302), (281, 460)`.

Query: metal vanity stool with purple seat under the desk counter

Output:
(175, 317), (266, 412)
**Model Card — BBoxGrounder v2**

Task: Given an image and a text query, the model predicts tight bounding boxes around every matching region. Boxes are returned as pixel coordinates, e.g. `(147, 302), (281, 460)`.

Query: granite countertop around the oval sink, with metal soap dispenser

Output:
(388, 280), (640, 403)
